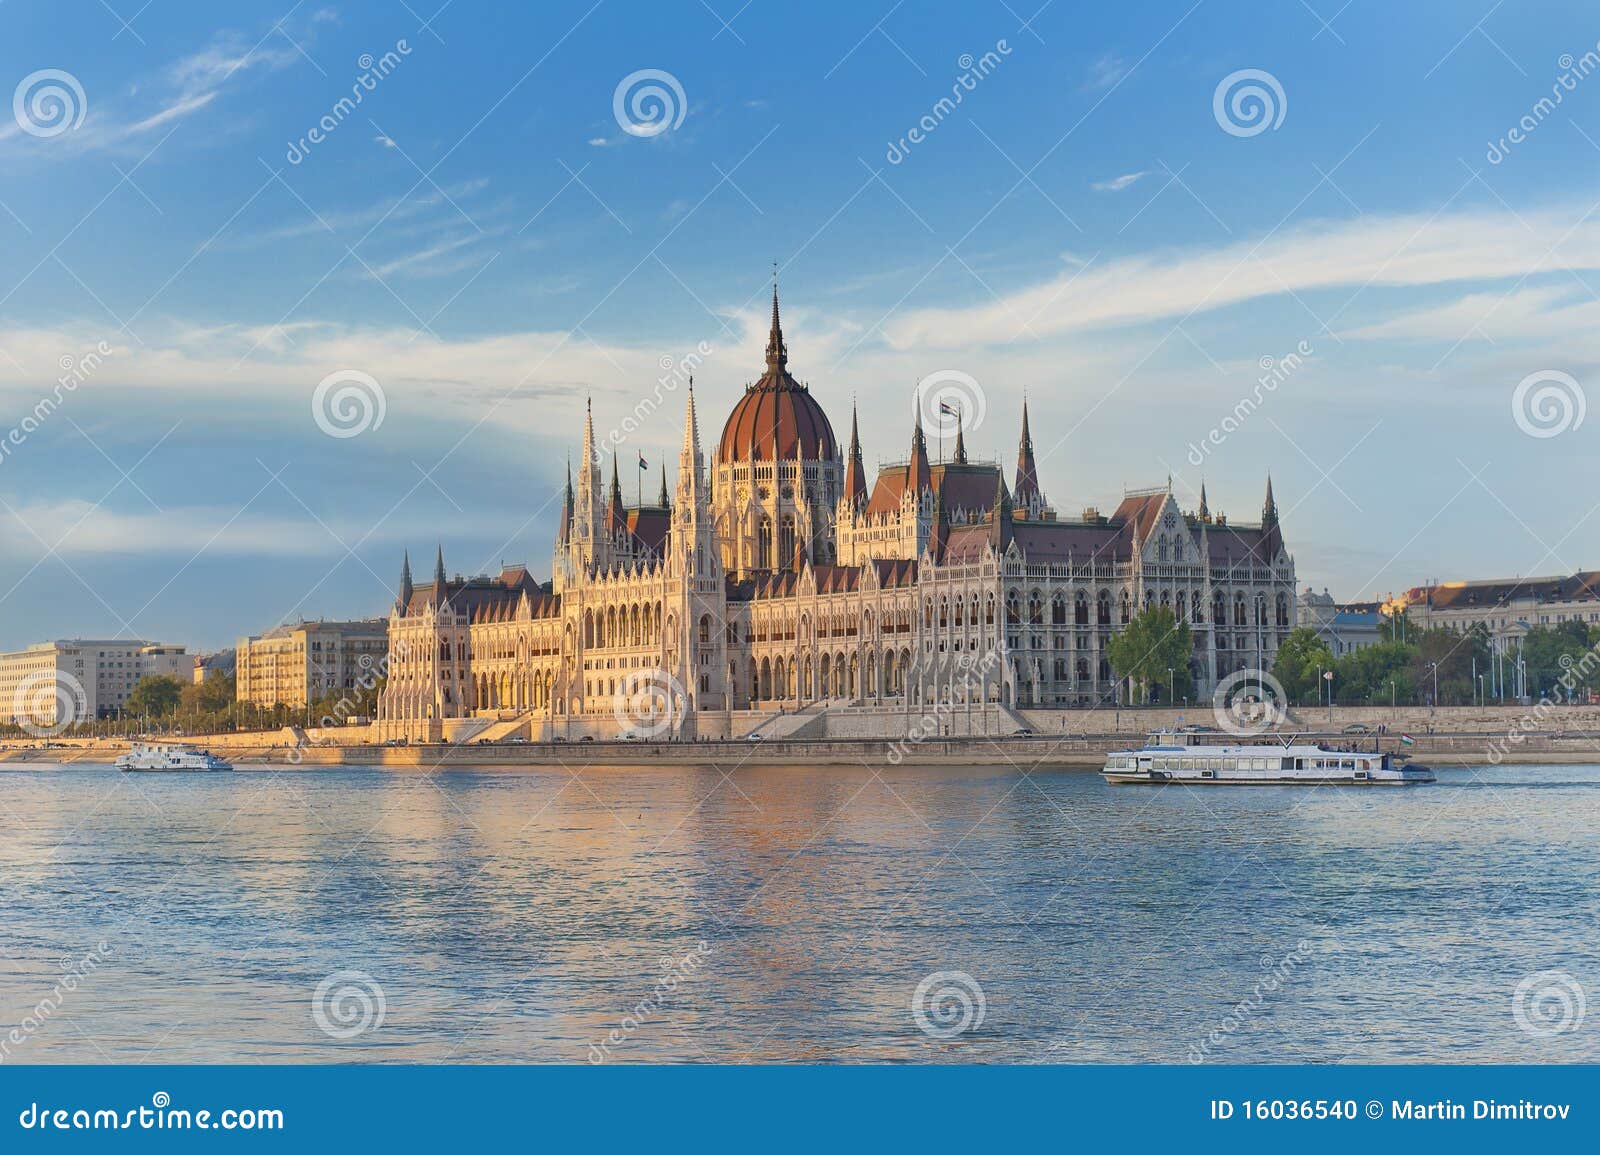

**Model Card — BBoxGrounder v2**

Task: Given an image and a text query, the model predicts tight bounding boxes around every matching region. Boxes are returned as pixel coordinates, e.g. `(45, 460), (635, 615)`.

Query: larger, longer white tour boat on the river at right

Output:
(1101, 731), (1434, 785)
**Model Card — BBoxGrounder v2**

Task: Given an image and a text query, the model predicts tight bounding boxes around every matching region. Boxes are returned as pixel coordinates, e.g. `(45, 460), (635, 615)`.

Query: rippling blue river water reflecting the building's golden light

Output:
(0, 765), (1600, 1064)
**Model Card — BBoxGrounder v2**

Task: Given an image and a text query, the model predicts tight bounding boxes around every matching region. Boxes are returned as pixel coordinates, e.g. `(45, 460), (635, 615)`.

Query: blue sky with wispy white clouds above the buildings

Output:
(0, 0), (1600, 648)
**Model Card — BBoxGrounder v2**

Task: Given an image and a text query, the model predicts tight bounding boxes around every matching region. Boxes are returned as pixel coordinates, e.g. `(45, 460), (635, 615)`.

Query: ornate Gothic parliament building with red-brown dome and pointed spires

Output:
(374, 291), (1296, 742)
